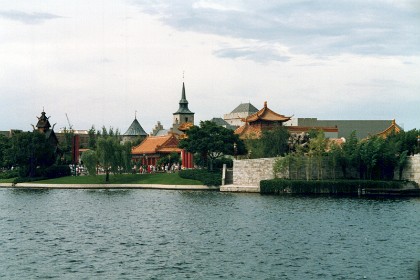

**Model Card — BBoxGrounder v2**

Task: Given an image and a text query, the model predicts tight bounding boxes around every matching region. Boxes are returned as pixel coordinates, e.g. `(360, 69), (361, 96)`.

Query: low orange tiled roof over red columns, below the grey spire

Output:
(131, 133), (181, 155)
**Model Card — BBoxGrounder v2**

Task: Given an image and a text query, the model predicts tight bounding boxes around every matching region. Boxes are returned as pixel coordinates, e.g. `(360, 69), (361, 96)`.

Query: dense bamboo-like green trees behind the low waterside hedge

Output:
(274, 126), (420, 180)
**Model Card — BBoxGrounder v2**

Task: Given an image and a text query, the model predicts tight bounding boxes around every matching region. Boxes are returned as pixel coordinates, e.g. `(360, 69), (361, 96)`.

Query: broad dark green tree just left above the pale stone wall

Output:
(179, 121), (246, 170)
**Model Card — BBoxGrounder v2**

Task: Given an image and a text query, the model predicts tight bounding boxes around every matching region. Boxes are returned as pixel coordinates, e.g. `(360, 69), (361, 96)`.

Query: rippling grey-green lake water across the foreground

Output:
(0, 189), (420, 279)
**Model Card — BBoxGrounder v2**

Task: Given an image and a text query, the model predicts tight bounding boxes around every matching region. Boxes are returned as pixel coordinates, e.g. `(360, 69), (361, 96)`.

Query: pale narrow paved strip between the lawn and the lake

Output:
(0, 183), (220, 191)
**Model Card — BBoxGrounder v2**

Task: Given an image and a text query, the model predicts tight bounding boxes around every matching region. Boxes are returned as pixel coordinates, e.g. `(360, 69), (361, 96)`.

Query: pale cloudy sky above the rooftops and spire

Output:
(0, 0), (420, 133)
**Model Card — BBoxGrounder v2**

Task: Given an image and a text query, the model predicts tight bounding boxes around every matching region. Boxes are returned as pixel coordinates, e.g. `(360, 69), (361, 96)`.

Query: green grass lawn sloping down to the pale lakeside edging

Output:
(33, 173), (202, 185)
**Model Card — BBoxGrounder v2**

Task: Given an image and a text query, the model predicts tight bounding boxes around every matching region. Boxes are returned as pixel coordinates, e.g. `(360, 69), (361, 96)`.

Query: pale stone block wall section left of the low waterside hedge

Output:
(233, 158), (276, 187)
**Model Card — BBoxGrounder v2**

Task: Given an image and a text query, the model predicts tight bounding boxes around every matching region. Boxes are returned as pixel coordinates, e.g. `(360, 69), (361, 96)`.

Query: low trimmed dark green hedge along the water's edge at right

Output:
(260, 179), (404, 195)
